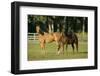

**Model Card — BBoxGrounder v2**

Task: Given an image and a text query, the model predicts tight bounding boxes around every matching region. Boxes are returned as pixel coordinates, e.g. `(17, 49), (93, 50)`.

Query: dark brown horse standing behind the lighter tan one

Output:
(59, 33), (78, 54)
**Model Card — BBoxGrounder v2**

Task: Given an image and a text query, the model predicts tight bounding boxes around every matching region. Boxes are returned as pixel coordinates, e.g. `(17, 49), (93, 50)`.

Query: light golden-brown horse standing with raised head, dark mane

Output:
(36, 25), (62, 54)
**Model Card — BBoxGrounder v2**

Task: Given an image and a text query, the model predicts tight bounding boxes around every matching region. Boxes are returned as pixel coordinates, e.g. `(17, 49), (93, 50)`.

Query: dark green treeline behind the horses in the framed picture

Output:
(28, 15), (88, 33)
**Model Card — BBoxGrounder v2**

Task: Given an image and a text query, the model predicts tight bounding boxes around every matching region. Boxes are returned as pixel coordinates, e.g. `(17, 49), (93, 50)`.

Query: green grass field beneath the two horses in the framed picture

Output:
(28, 36), (88, 61)
